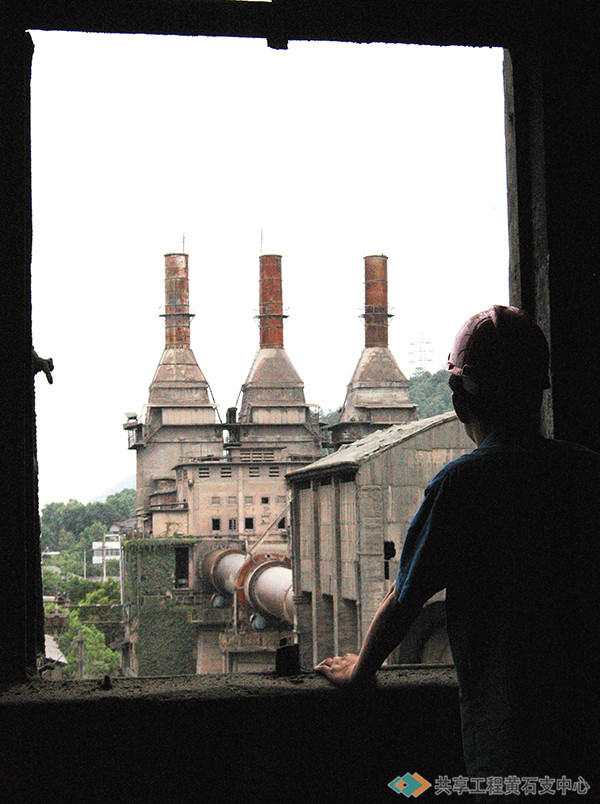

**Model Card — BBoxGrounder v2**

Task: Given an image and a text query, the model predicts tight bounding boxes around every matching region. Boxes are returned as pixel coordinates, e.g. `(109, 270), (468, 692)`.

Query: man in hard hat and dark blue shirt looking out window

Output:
(316, 306), (600, 800)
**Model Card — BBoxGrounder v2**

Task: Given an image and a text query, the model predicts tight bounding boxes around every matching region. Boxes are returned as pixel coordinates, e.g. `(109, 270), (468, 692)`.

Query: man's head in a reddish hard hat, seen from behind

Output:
(446, 305), (550, 440)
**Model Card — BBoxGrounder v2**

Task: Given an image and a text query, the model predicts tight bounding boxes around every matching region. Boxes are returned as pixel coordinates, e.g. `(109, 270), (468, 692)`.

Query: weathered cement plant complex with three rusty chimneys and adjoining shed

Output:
(123, 254), (470, 675)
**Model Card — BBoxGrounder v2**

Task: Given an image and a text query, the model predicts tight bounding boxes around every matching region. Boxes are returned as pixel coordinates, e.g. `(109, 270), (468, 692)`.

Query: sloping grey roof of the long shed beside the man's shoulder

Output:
(286, 411), (456, 477)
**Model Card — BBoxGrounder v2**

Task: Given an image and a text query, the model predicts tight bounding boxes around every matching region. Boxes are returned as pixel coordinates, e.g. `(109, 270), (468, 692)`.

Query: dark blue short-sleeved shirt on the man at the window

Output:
(396, 435), (600, 779)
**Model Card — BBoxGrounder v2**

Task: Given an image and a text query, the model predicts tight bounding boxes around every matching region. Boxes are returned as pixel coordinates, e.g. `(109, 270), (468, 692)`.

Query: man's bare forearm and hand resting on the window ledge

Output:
(315, 584), (422, 686)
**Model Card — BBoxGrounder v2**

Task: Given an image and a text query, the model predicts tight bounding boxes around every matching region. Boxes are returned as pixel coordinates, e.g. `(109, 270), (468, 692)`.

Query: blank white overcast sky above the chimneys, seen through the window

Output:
(27, 31), (508, 505)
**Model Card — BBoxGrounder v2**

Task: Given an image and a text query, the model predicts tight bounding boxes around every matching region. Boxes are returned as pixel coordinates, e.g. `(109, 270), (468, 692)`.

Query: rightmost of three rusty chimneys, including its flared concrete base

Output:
(332, 254), (417, 447)
